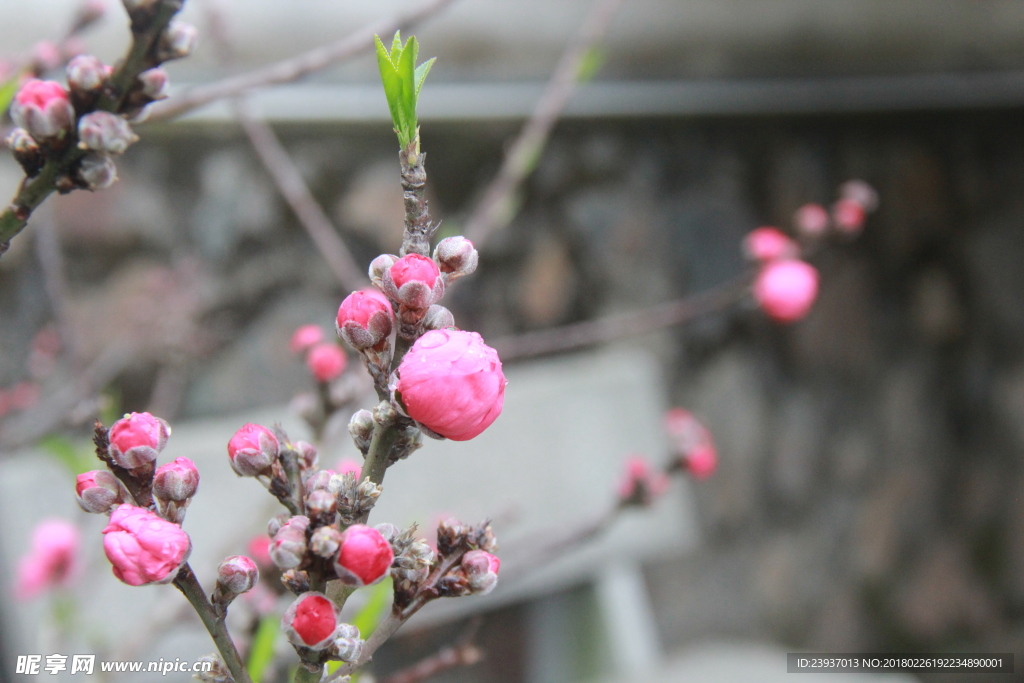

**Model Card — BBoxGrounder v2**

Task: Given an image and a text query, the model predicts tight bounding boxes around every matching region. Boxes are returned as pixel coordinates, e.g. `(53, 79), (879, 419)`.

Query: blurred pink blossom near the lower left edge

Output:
(15, 518), (80, 600)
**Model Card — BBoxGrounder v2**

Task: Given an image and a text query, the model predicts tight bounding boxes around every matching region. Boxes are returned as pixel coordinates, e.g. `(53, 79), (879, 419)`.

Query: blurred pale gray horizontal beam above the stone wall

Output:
(167, 72), (1024, 123)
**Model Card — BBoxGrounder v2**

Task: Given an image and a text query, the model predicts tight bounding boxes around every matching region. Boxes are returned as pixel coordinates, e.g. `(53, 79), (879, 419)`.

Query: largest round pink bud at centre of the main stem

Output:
(394, 330), (507, 441)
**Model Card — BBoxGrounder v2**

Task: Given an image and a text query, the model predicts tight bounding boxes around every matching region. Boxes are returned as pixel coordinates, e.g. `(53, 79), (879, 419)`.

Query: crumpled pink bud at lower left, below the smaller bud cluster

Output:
(103, 505), (191, 586)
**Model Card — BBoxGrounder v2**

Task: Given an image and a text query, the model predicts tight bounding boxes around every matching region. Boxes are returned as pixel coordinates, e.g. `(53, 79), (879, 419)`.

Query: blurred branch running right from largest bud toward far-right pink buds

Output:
(492, 273), (751, 360)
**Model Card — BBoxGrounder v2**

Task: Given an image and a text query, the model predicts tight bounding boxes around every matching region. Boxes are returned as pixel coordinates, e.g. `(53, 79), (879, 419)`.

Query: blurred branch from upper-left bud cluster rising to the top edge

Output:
(146, 0), (454, 121)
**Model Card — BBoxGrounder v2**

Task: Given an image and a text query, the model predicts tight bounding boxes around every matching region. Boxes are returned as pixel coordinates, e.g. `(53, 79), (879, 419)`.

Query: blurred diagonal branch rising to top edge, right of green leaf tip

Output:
(464, 0), (625, 248)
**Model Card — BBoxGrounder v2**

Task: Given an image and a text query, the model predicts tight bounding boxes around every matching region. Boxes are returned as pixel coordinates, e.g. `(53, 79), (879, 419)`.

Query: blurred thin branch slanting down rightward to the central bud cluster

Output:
(234, 102), (370, 290)
